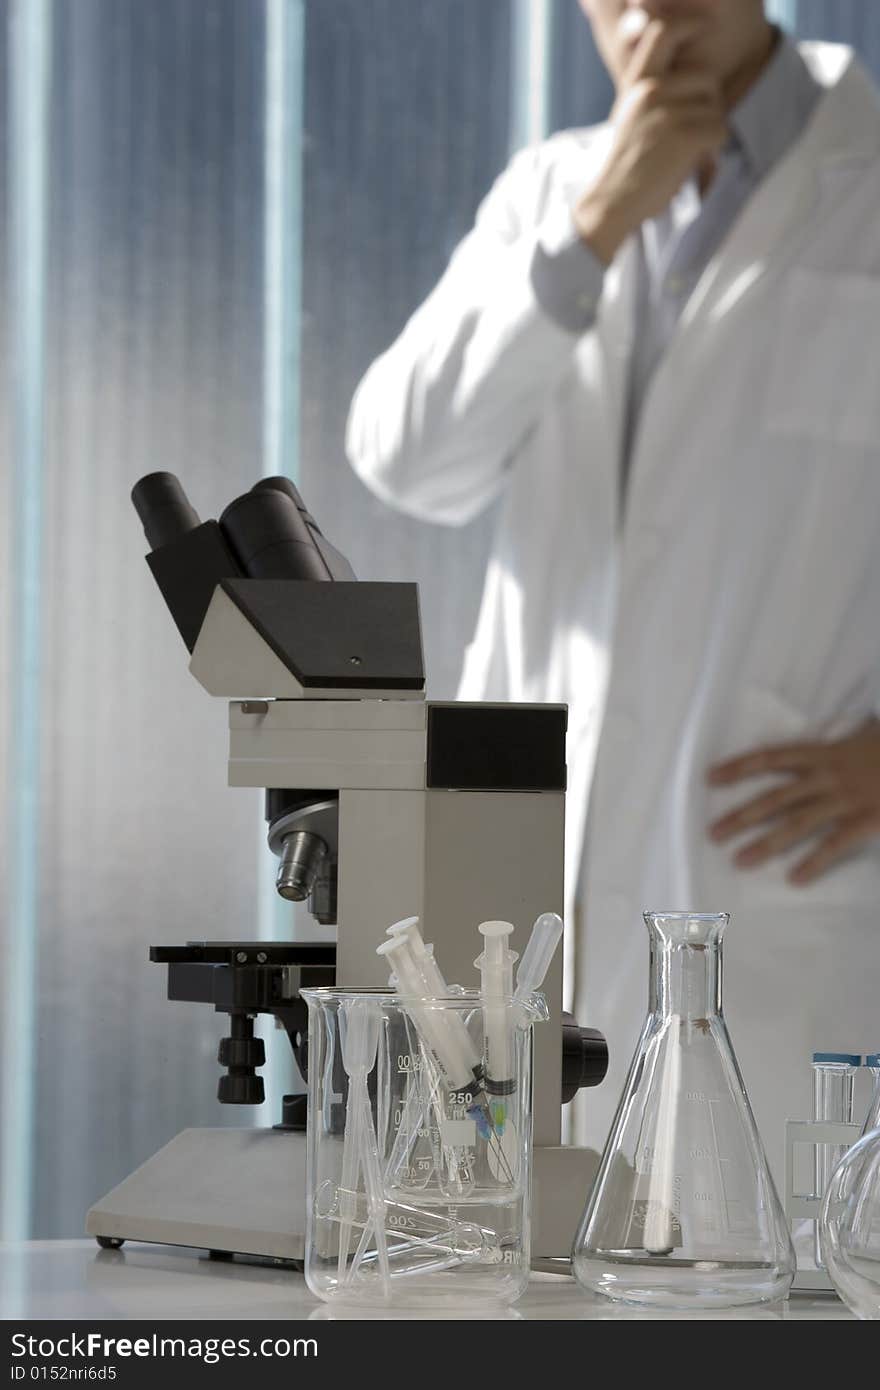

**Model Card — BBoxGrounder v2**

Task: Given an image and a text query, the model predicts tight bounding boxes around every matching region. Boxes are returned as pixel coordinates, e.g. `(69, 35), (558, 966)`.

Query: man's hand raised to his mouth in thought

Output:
(574, 18), (727, 265)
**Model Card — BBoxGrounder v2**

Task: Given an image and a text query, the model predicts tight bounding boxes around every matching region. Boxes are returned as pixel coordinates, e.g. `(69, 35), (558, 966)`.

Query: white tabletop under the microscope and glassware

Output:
(0, 1240), (852, 1322)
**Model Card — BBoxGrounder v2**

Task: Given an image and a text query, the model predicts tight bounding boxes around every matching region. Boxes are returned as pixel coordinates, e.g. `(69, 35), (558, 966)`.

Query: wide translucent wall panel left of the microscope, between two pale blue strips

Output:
(33, 0), (264, 1236)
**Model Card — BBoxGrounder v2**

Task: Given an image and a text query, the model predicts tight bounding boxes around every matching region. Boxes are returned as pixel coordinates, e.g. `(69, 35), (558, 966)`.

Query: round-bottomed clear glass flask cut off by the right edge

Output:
(819, 1129), (880, 1321)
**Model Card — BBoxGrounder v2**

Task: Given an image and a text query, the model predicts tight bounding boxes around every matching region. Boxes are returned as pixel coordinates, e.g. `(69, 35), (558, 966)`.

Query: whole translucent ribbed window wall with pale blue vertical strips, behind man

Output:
(0, 0), (880, 1238)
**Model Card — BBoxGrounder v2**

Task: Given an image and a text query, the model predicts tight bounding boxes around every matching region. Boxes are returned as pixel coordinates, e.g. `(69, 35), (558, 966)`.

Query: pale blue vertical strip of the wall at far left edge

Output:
(0, 0), (50, 1240)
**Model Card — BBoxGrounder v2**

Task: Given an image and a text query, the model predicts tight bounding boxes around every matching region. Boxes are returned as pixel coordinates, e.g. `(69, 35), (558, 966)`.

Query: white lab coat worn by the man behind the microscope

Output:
(348, 44), (880, 1180)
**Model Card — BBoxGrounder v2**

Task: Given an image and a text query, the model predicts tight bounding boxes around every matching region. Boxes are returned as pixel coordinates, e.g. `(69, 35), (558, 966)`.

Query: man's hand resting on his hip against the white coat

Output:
(709, 719), (880, 884)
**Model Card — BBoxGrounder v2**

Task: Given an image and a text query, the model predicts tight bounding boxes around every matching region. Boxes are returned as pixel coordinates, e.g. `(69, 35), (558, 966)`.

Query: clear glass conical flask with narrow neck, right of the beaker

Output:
(571, 912), (795, 1308)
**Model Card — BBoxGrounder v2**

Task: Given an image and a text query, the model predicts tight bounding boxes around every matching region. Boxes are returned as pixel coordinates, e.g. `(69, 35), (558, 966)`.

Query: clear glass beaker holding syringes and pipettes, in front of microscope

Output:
(302, 990), (546, 1307)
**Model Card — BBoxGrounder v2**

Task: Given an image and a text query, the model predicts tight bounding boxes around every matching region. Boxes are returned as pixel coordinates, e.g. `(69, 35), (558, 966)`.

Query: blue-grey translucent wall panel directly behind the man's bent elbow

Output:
(302, 0), (512, 695)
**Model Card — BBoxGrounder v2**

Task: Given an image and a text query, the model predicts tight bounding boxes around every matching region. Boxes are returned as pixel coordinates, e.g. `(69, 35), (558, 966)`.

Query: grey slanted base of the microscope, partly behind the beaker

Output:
(86, 1129), (598, 1262)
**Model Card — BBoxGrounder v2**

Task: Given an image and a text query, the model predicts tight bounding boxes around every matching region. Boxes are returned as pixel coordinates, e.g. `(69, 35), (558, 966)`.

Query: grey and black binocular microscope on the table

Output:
(86, 473), (608, 1265)
